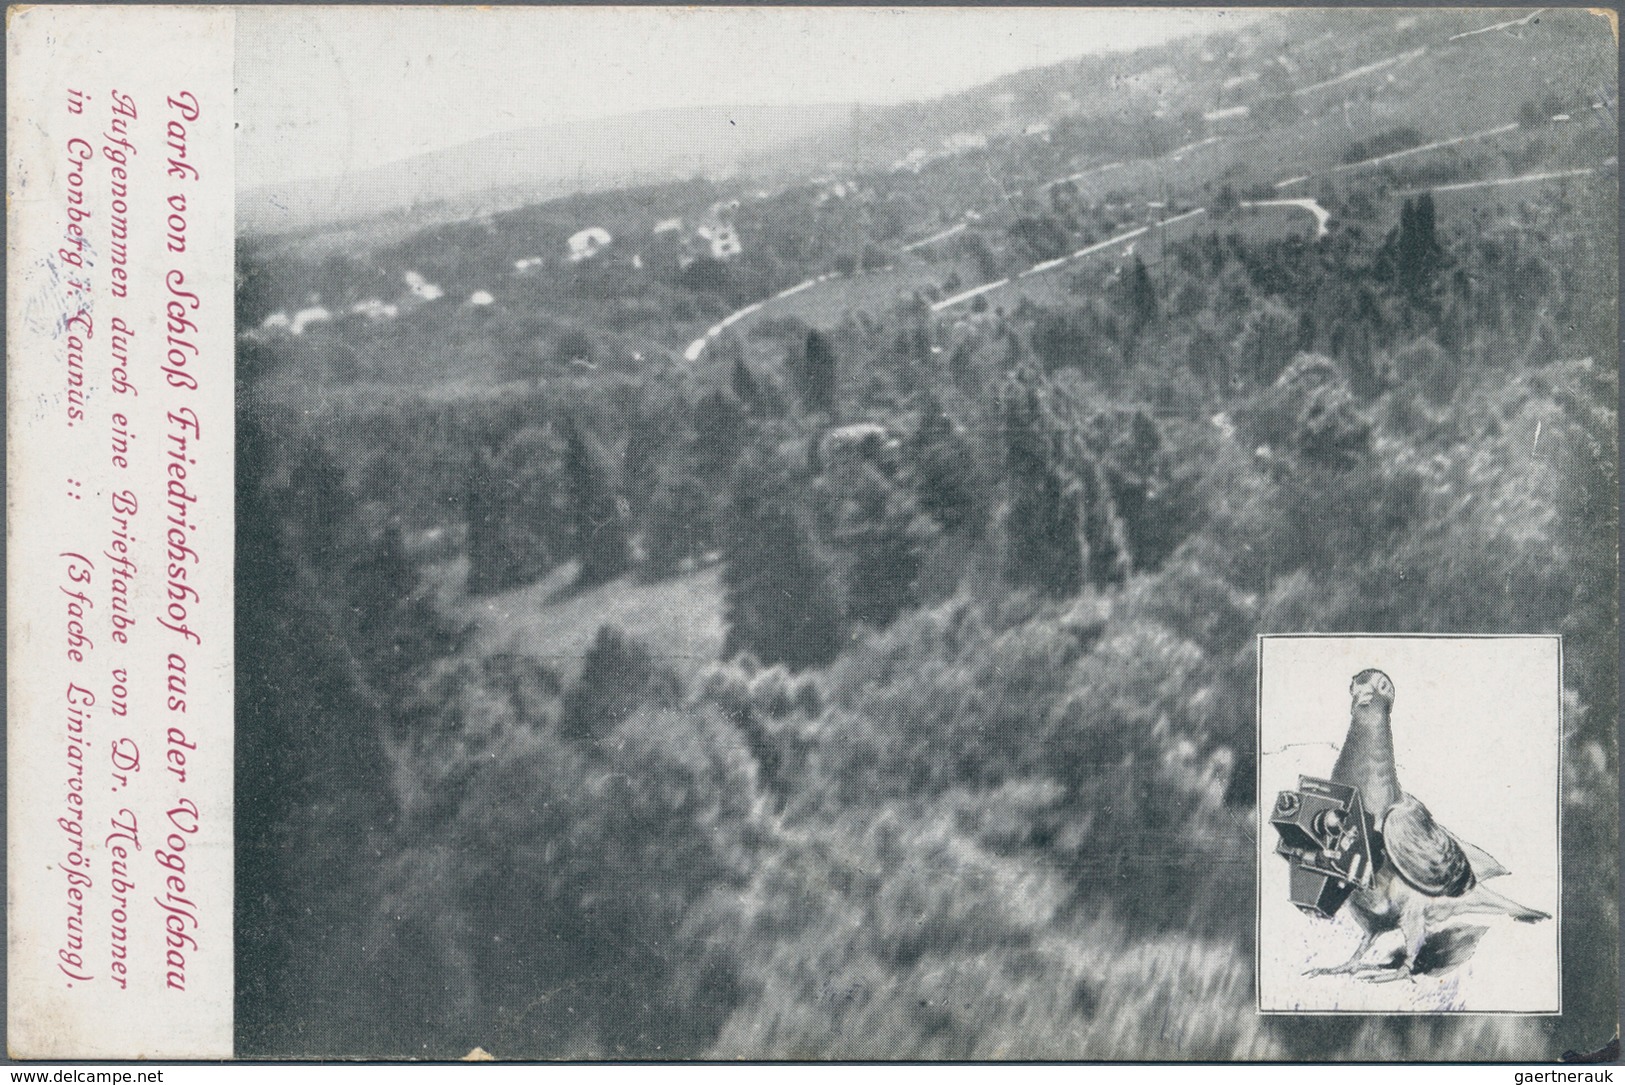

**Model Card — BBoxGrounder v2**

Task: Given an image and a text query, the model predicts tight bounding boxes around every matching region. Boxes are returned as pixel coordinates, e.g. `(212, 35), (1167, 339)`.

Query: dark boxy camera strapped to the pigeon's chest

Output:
(1269, 776), (1381, 919)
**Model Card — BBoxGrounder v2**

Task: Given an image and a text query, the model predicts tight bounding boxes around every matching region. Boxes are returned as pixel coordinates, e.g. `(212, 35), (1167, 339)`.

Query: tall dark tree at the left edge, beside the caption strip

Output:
(232, 384), (395, 1057)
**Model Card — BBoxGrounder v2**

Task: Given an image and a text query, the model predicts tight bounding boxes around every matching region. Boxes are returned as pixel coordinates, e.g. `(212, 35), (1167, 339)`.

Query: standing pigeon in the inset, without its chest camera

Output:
(1307, 669), (1550, 981)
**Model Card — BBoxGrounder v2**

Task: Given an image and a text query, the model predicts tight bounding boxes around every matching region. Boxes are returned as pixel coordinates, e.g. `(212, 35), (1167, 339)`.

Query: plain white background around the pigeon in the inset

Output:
(1258, 637), (1562, 1014)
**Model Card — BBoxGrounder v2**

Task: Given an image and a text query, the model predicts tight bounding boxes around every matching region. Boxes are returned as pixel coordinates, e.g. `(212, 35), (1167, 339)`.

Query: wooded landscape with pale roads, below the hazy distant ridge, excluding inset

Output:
(237, 10), (1619, 1061)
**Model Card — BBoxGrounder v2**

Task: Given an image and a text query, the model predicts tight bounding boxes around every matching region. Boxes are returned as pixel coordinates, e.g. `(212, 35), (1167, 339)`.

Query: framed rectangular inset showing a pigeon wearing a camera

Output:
(1258, 637), (1562, 1014)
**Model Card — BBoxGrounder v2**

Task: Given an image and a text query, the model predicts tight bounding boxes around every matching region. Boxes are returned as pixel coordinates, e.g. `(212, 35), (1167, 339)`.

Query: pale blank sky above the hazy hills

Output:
(237, 6), (1253, 187)
